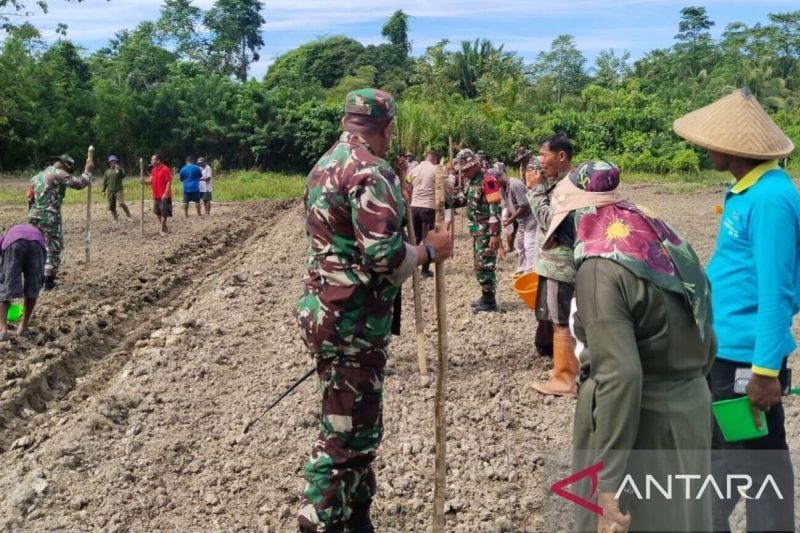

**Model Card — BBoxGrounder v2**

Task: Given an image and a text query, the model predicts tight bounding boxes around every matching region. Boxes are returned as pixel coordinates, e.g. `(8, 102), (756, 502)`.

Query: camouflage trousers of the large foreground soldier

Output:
(297, 349), (386, 533)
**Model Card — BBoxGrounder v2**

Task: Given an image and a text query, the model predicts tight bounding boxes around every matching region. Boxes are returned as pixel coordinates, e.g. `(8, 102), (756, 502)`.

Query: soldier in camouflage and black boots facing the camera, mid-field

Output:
(447, 148), (502, 313)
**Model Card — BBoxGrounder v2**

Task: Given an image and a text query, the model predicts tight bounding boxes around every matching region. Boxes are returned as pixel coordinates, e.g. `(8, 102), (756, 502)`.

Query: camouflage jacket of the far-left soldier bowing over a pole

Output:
(28, 166), (94, 225)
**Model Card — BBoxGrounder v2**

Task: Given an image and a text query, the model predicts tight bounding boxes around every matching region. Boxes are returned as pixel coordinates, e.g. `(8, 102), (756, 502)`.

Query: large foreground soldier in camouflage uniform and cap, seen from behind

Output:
(295, 89), (450, 532)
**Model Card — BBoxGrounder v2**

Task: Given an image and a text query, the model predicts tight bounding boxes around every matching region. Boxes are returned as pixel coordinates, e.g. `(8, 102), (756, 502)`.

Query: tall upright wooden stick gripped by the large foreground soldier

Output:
(433, 167), (447, 533)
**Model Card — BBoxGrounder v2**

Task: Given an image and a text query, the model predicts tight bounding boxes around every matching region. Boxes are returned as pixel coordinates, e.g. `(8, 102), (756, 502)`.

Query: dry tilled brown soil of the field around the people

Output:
(0, 186), (800, 532)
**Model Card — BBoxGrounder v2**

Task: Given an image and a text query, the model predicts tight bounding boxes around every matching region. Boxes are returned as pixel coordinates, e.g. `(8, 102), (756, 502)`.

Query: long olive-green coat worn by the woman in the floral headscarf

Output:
(573, 258), (716, 531)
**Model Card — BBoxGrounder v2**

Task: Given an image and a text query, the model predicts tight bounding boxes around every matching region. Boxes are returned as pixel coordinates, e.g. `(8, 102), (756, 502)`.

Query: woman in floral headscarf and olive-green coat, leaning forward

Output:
(546, 161), (716, 531)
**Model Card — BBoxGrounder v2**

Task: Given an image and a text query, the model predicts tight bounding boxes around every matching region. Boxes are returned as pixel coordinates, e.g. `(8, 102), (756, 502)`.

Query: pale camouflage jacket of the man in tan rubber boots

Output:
(528, 174), (576, 283)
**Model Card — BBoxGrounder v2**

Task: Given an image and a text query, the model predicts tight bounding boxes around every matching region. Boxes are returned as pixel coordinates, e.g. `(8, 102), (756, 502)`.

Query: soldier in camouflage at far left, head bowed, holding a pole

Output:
(28, 154), (94, 290)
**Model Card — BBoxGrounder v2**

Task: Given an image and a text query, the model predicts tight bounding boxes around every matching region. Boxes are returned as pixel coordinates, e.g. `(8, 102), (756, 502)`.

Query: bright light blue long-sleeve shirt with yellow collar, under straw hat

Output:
(708, 161), (800, 376)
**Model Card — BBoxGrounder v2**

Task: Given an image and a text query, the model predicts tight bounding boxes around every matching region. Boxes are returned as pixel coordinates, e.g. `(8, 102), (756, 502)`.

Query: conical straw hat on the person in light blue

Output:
(672, 88), (794, 159)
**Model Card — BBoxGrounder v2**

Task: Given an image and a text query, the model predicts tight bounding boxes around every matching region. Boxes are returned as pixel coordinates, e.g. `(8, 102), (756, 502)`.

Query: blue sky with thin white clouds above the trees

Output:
(9, 0), (800, 79)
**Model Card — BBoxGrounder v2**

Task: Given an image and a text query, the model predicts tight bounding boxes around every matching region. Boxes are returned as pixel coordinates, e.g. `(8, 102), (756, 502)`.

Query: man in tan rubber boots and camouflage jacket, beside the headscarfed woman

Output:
(528, 135), (579, 396)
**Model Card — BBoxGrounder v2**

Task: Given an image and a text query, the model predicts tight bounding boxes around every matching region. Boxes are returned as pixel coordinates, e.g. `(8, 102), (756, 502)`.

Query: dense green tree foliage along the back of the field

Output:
(0, 4), (800, 173)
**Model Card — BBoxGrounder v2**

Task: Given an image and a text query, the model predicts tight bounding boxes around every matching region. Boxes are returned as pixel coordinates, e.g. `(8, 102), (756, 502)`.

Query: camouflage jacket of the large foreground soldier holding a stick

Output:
(295, 132), (416, 356)
